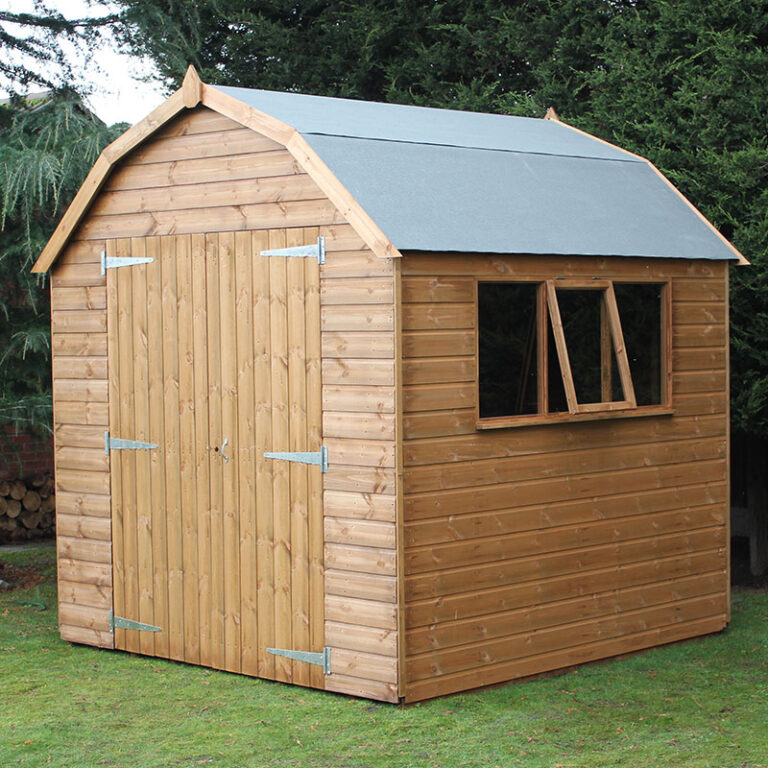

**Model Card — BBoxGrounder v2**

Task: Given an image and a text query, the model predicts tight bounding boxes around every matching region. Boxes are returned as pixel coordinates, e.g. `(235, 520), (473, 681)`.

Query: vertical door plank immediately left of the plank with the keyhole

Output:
(191, 235), (212, 666)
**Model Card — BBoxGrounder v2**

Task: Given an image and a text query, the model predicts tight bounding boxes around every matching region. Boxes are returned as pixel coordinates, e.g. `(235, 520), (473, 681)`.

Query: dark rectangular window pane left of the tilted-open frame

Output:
(478, 283), (538, 419)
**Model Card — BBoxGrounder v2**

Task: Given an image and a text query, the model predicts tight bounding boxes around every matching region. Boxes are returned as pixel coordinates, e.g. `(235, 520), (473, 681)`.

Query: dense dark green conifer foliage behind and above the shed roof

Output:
(112, 0), (768, 434)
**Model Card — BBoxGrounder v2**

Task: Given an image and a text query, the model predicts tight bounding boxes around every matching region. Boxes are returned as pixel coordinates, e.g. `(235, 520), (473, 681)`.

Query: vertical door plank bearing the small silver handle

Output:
(219, 232), (240, 672)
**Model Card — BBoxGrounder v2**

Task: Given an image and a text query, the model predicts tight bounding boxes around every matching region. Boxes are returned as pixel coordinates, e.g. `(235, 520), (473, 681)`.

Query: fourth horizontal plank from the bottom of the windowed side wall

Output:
(405, 550), (727, 629)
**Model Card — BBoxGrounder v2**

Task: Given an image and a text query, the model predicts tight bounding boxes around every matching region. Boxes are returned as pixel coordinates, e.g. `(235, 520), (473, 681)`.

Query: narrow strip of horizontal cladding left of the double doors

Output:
(51, 240), (113, 648)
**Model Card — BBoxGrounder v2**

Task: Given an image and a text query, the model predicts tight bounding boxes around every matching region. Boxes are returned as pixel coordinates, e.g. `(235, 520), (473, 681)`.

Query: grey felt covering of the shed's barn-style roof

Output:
(220, 87), (737, 259)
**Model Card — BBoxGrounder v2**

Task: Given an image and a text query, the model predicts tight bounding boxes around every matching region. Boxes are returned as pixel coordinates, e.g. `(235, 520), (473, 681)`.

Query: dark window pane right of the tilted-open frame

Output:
(613, 283), (663, 405)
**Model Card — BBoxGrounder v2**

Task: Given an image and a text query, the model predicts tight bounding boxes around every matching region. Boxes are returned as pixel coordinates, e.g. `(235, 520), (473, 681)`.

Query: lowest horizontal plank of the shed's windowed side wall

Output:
(406, 613), (726, 702)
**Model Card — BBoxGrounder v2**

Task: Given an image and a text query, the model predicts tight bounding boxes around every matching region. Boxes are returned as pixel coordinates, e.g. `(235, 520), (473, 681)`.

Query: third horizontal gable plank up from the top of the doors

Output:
(104, 149), (302, 191)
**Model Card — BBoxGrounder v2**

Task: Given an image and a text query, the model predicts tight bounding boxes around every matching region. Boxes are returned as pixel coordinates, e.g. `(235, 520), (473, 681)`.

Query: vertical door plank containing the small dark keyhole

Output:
(205, 235), (226, 669)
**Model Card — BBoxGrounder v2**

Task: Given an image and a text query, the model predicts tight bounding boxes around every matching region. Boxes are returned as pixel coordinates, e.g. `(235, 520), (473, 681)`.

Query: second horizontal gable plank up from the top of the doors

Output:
(90, 173), (325, 216)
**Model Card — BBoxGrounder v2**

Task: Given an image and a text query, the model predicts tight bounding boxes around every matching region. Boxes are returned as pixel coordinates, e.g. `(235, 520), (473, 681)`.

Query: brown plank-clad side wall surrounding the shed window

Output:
(402, 254), (728, 701)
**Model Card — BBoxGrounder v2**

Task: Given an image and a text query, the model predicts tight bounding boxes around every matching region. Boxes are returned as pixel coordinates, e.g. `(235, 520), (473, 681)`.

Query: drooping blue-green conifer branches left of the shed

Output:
(0, 92), (119, 428)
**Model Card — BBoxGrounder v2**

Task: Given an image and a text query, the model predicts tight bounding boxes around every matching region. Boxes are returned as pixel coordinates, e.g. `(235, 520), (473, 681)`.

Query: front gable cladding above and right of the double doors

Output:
(55, 108), (398, 701)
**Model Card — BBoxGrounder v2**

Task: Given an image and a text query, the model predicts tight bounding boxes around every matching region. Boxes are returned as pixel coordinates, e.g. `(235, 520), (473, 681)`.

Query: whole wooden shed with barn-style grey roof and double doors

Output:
(35, 70), (744, 702)
